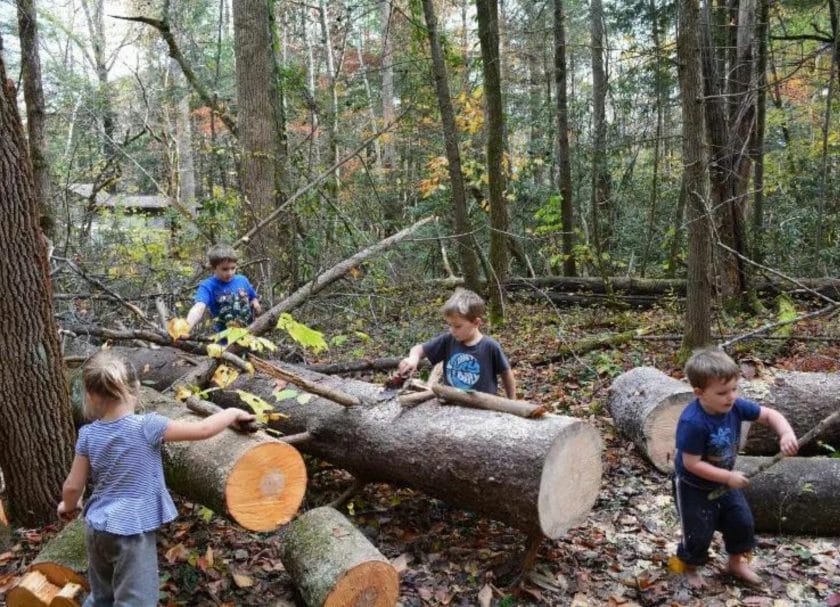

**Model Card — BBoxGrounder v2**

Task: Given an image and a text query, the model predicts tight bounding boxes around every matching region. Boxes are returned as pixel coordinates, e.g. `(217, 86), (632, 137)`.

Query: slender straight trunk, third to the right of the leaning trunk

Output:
(589, 0), (614, 265)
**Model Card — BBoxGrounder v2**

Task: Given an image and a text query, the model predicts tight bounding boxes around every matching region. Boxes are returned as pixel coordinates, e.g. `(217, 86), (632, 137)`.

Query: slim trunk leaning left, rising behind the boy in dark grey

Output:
(423, 0), (479, 291)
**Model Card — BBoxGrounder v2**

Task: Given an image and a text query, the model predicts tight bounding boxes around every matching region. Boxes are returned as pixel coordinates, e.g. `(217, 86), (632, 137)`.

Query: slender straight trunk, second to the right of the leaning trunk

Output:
(554, 0), (577, 276)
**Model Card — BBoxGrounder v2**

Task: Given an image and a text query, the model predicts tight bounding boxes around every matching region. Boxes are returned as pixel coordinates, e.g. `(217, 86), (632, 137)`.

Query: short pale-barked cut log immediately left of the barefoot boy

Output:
(607, 367), (694, 472)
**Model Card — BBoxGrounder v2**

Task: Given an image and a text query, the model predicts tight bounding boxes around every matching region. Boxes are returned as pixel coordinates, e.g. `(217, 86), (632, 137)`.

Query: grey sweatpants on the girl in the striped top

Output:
(83, 527), (160, 607)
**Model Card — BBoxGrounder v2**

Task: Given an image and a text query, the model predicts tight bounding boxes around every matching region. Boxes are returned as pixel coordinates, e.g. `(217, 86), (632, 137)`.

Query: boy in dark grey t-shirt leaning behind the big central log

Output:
(399, 289), (516, 399)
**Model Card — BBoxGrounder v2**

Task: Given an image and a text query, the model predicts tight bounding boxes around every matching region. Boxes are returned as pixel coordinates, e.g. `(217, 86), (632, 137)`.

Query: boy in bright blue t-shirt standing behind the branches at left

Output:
(187, 244), (262, 333)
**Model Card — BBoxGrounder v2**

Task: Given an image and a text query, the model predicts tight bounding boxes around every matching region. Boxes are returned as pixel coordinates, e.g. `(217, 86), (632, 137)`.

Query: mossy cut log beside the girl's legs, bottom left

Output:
(29, 517), (90, 590)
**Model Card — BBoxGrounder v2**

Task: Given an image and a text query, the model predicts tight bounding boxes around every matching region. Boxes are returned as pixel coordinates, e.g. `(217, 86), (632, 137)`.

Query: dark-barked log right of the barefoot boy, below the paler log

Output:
(735, 456), (840, 536)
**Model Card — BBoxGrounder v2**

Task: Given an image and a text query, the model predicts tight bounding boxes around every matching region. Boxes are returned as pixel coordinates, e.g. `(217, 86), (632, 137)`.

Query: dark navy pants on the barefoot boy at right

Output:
(673, 476), (755, 565)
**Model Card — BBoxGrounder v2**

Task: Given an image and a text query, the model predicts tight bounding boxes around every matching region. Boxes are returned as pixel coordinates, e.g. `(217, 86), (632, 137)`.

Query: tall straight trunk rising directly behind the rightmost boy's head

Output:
(677, 0), (712, 354)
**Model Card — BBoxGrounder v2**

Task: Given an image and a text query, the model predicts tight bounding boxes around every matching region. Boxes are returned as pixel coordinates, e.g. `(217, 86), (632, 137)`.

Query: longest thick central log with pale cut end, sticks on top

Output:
(120, 350), (601, 538)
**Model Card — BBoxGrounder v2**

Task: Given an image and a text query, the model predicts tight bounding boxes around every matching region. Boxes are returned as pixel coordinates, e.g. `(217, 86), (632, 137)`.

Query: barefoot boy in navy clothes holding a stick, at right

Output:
(674, 350), (799, 585)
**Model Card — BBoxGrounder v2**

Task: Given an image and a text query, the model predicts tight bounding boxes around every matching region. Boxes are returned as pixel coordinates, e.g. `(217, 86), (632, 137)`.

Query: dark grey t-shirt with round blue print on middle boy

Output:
(423, 333), (510, 394)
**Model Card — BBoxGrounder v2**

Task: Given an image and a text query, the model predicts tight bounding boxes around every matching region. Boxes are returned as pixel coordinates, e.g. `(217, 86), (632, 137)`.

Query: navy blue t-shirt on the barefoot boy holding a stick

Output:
(674, 398), (761, 490)
